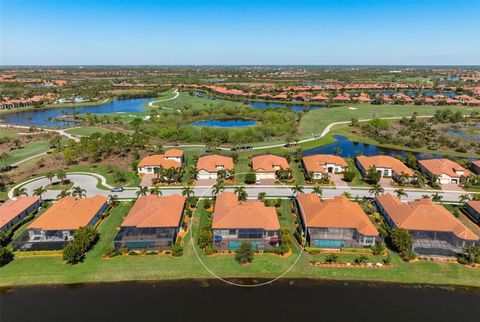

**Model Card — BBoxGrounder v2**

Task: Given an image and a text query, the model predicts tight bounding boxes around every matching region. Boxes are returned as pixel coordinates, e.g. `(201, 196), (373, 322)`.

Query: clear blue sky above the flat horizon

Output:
(0, 0), (480, 65)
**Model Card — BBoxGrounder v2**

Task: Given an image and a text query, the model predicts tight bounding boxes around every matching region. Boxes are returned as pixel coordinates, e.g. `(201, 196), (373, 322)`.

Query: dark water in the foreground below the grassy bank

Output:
(1, 280), (480, 322)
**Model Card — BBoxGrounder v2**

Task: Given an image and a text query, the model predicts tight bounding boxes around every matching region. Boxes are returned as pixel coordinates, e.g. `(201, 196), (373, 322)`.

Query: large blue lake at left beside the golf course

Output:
(0, 98), (153, 126)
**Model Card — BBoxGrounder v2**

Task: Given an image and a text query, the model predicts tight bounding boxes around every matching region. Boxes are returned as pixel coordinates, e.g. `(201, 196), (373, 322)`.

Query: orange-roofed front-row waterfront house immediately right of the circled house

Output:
(297, 194), (380, 248)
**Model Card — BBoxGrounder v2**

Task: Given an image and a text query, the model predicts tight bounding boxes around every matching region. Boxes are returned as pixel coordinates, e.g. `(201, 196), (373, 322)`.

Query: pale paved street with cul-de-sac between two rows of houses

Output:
(9, 173), (472, 202)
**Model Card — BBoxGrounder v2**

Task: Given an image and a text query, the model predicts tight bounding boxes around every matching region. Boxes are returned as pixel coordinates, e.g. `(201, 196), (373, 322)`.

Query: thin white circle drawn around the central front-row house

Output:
(190, 172), (307, 287)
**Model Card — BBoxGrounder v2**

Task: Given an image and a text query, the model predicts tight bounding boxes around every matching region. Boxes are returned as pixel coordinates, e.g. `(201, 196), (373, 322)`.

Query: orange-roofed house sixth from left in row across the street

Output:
(418, 159), (471, 184)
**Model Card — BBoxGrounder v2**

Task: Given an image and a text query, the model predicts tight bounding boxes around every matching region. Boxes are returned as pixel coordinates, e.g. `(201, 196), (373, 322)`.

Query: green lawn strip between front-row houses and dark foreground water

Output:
(0, 201), (480, 287)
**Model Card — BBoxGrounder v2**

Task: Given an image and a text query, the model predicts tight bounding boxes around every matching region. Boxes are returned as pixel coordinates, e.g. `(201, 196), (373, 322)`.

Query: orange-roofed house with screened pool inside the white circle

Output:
(212, 192), (280, 250)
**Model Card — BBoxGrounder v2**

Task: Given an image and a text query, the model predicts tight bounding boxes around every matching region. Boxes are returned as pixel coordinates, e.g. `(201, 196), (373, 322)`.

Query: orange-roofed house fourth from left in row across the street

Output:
(302, 154), (348, 179)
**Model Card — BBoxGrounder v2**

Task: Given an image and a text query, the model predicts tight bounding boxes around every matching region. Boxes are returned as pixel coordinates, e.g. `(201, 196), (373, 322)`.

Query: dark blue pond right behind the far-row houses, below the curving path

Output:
(303, 135), (443, 160)
